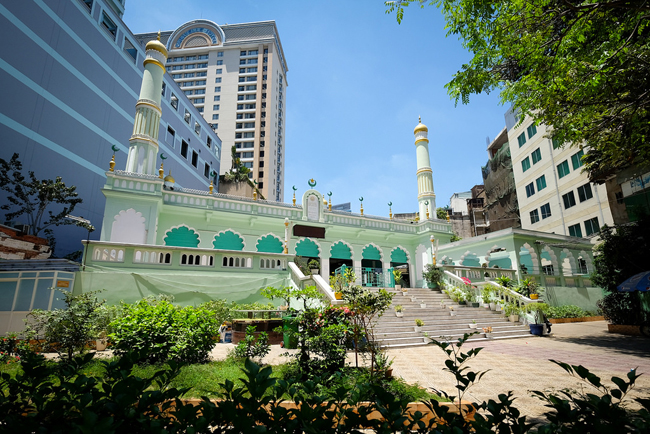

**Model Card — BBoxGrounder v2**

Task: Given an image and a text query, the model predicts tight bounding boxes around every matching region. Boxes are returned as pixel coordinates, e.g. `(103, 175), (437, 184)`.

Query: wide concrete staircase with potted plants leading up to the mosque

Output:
(375, 288), (531, 348)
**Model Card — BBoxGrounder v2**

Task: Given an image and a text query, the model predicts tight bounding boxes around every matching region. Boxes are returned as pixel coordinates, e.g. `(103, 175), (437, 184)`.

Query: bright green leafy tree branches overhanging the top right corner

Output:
(385, 0), (650, 182)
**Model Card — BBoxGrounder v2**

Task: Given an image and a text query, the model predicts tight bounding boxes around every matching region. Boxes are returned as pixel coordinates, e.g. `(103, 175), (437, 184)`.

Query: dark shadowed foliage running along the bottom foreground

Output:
(0, 334), (650, 434)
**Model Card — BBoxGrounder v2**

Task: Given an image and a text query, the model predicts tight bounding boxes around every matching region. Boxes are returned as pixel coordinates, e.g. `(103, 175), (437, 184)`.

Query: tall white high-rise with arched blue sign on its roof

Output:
(136, 19), (288, 201)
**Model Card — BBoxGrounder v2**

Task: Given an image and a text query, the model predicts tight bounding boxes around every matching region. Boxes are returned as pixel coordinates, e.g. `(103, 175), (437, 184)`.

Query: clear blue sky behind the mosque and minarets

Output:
(124, 0), (506, 216)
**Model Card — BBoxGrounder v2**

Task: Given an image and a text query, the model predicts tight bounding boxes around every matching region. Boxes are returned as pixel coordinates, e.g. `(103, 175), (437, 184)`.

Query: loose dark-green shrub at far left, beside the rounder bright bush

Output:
(27, 291), (105, 360)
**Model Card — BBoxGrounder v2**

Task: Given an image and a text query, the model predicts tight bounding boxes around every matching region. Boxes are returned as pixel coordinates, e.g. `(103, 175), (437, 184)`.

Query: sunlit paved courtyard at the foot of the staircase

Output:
(212, 321), (650, 417)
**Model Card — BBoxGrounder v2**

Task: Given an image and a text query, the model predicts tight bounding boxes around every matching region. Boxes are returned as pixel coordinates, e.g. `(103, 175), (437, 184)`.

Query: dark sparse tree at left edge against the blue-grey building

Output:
(0, 154), (95, 239)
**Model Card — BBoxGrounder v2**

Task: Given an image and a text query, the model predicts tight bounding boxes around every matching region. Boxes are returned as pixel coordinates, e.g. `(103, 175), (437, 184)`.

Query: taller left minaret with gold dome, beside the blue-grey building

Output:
(126, 32), (167, 175)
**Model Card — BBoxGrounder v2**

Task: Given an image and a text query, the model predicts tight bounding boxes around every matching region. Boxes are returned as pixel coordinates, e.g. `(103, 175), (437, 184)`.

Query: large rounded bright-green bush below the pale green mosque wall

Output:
(110, 298), (220, 363)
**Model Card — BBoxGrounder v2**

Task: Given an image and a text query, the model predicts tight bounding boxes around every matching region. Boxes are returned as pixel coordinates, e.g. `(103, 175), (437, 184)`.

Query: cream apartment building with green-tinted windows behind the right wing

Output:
(505, 110), (614, 237)
